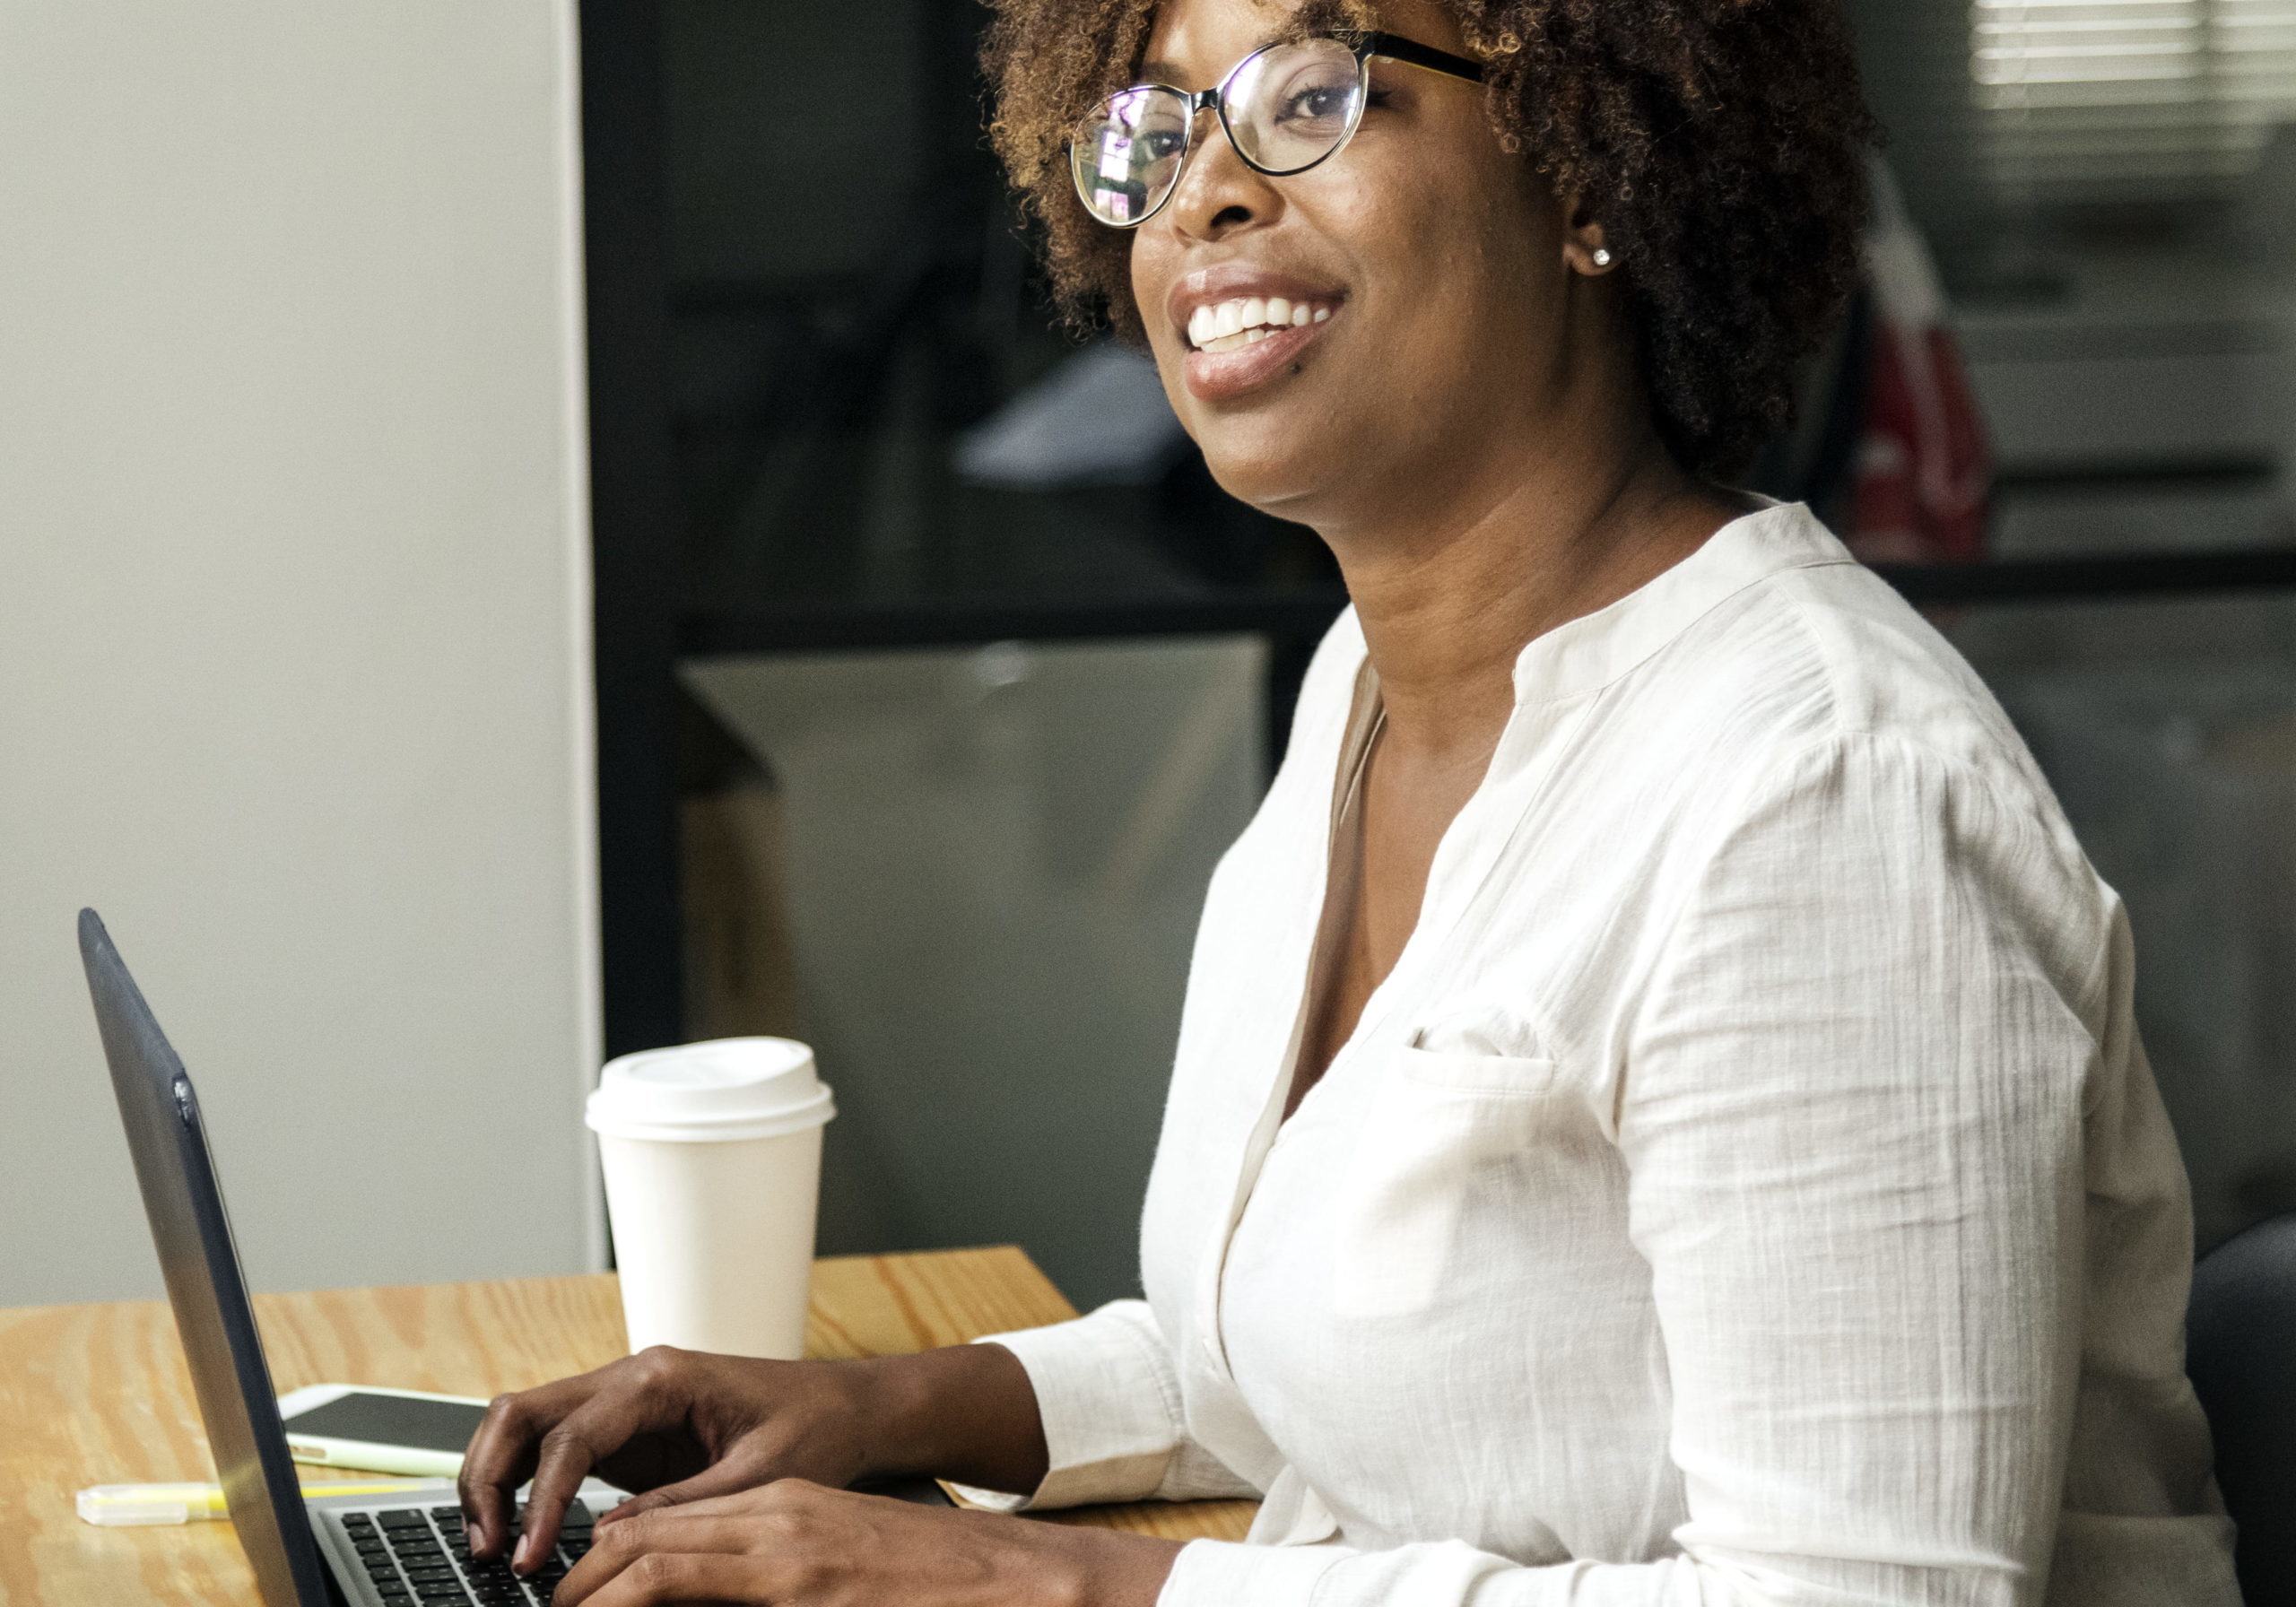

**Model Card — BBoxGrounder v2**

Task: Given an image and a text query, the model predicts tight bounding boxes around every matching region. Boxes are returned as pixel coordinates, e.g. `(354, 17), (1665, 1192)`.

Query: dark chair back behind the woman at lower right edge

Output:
(2186, 1212), (2296, 1607)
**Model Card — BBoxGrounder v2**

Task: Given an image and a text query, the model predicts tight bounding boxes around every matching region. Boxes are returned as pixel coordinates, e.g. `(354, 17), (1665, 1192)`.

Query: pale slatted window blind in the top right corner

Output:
(1970, 0), (2296, 206)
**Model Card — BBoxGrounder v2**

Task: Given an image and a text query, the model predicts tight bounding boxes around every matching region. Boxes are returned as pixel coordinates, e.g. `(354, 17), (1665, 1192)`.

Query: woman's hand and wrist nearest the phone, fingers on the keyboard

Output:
(459, 1345), (1045, 1570)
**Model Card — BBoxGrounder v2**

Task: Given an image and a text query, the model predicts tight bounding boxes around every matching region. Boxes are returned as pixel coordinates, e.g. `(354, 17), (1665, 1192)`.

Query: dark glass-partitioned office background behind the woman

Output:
(583, 0), (2296, 1302)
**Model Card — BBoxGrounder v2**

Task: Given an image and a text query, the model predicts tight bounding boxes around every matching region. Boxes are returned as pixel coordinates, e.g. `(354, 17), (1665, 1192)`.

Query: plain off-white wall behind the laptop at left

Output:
(0, 0), (597, 1304)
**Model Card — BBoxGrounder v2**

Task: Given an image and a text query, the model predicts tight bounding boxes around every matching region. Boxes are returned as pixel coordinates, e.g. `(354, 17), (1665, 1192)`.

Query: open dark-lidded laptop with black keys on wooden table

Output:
(81, 909), (951, 1607)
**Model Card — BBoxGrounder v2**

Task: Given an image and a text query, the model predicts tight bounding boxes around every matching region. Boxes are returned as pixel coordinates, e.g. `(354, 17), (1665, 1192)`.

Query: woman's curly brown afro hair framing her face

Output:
(983, 0), (1876, 477)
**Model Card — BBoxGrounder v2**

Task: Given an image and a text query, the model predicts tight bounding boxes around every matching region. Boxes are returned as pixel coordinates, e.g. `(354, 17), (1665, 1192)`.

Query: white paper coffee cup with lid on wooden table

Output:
(587, 1038), (836, 1361)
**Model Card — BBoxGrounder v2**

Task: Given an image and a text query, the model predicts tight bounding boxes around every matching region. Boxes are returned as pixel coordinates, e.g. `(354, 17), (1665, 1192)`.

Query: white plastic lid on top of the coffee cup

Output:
(586, 1038), (836, 1143)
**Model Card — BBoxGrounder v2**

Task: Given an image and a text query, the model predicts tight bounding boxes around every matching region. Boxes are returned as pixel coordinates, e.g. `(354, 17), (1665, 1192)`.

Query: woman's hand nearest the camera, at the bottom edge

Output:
(556, 1479), (1180, 1607)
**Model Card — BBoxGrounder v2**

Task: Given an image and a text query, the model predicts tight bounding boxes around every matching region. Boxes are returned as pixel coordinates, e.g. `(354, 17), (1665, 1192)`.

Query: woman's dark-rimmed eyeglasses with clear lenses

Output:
(1067, 28), (1483, 230)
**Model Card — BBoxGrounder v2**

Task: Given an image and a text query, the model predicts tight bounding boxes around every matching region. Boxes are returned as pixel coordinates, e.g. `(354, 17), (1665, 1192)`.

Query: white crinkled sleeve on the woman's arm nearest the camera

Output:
(1161, 734), (2176, 1607)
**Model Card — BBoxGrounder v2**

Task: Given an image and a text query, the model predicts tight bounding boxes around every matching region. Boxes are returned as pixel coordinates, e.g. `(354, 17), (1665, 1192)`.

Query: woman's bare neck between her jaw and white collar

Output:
(1325, 434), (1743, 764)
